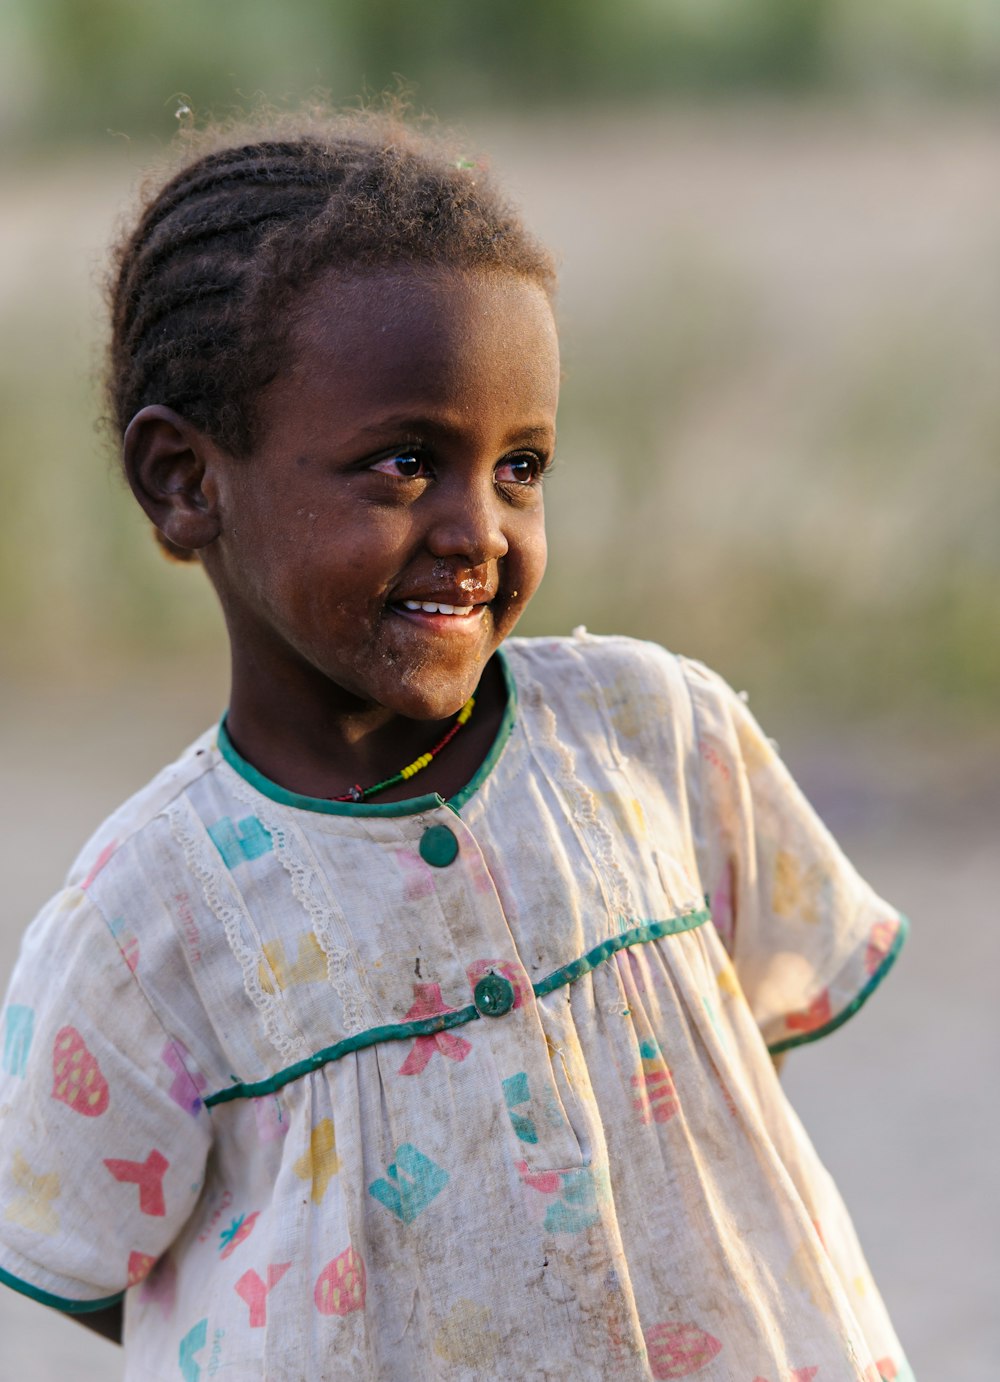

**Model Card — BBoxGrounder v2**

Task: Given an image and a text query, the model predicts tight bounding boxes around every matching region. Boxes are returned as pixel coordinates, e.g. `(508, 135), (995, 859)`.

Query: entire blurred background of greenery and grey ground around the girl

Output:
(0, 8), (1000, 1382)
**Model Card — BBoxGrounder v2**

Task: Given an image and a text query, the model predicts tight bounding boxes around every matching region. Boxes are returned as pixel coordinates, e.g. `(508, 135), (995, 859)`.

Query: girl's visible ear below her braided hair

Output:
(123, 404), (220, 551)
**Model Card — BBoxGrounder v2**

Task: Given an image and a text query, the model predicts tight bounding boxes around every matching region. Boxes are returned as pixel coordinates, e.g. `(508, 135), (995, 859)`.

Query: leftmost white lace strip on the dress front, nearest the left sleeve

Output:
(164, 797), (308, 1060)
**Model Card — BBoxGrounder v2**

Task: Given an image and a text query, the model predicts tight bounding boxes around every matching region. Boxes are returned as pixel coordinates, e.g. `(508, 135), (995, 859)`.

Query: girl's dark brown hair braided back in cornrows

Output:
(106, 112), (555, 556)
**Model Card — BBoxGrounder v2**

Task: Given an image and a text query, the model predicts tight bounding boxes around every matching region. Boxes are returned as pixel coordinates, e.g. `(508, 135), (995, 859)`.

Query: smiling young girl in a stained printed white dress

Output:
(0, 117), (912, 1382)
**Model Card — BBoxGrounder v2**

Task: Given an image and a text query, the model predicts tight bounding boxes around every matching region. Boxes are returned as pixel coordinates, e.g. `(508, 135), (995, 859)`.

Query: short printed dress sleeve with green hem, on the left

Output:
(0, 887), (210, 1313)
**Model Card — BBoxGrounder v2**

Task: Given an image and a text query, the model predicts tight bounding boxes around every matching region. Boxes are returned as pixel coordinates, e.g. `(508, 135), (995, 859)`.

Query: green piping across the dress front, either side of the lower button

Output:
(204, 911), (711, 1108)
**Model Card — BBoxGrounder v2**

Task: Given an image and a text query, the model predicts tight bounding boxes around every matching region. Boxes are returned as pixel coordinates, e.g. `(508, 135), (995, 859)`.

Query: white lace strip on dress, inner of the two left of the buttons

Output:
(228, 770), (381, 1035)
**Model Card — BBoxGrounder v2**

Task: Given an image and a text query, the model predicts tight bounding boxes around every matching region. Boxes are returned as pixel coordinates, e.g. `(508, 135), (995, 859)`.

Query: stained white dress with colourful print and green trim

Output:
(0, 633), (912, 1382)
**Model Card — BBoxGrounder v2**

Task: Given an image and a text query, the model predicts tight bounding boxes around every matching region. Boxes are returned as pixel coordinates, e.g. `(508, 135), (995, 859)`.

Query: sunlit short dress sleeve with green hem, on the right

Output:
(684, 661), (906, 1053)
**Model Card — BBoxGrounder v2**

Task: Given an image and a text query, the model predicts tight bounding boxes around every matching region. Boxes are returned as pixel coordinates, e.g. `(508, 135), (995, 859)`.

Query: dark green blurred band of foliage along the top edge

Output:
(0, 0), (1000, 146)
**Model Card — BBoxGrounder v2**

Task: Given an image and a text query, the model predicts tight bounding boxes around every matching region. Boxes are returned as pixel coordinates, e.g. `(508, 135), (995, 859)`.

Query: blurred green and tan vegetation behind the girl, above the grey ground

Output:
(0, 0), (1000, 724)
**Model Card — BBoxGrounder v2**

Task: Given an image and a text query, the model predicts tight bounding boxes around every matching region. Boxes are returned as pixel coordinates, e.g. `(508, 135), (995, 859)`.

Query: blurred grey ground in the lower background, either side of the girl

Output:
(0, 672), (1000, 1382)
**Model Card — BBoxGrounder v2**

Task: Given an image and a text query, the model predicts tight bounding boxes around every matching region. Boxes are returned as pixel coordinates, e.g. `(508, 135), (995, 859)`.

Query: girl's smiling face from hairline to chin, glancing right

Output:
(203, 268), (559, 719)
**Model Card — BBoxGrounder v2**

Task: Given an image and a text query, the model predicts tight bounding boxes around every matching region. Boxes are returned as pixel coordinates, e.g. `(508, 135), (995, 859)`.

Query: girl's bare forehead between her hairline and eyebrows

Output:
(277, 267), (559, 415)
